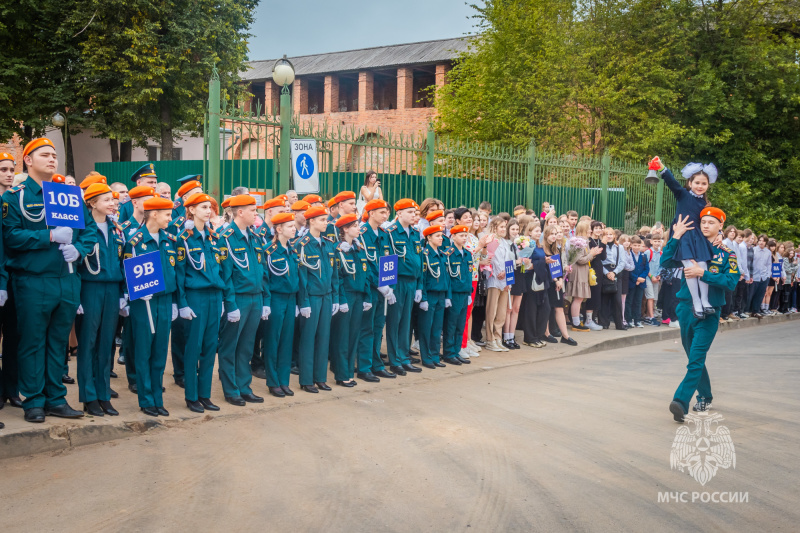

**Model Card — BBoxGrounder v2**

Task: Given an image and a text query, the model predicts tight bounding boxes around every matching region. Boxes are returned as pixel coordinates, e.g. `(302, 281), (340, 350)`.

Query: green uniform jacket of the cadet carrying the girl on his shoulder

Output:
(661, 235), (739, 307)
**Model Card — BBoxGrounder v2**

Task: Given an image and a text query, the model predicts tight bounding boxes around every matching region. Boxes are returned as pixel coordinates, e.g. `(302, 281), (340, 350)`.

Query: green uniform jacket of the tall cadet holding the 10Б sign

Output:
(3, 177), (97, 277)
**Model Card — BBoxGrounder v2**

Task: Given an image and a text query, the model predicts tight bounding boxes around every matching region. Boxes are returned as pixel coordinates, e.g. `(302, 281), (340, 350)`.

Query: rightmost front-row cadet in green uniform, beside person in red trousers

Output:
(442, 226), (473, 364)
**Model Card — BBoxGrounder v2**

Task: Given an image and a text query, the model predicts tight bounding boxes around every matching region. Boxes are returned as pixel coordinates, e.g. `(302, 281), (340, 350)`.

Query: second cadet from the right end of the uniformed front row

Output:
(419, 223), (450, 369)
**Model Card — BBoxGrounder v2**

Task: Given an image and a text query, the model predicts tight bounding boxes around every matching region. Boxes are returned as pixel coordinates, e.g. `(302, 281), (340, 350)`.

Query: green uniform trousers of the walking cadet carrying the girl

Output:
(673, 300), (720, 413)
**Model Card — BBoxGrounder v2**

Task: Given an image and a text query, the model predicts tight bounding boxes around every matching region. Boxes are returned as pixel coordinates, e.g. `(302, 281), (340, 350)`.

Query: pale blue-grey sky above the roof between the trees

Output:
(244, 0), (482, 60)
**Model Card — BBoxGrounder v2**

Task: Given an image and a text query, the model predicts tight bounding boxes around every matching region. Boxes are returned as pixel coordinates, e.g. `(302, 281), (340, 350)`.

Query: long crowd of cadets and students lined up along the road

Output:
(0, 139), (798, 427)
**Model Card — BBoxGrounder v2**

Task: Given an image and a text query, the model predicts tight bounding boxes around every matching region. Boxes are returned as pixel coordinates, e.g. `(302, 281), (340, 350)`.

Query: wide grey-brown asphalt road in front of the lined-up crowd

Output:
(0, 323), (800, 532)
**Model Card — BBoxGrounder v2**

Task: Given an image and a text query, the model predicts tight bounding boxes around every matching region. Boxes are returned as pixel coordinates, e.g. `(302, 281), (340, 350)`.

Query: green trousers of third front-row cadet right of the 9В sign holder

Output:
(263, 292), (297, 387)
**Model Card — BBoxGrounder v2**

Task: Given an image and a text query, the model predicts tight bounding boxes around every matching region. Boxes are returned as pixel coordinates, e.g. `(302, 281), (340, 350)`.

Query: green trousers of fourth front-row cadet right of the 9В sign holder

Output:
(297, 293), (333, 385)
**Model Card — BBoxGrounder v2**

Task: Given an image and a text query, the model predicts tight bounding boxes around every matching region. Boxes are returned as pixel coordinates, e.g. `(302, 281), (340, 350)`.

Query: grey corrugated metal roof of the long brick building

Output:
(240, 37), (471, 81)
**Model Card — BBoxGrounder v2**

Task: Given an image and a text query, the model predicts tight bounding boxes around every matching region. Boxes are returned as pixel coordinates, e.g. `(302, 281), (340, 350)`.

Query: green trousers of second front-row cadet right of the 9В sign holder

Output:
(219, 293), (264, 396)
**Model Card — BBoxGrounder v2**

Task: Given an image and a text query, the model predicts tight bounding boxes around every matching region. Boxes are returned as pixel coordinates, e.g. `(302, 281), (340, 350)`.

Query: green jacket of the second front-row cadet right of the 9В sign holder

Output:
(220, 223), (269, 313)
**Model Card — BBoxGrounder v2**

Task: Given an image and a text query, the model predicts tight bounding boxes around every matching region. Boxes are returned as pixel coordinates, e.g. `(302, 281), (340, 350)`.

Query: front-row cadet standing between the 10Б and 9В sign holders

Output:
(78, 183), (127, 416)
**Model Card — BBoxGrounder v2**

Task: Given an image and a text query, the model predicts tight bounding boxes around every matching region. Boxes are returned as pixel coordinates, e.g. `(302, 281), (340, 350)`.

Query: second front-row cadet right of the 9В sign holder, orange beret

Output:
(219, 194), (270, 406)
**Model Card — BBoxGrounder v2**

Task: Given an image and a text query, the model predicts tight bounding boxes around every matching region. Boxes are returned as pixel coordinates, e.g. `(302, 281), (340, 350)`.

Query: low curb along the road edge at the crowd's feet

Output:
(0, 313), (800, 460)
